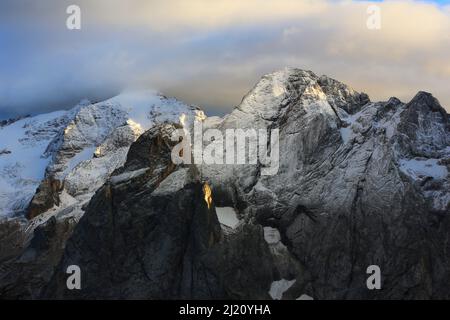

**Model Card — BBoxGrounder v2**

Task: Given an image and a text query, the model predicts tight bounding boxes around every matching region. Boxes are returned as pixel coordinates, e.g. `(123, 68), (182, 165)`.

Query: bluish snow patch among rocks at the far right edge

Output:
(399, 159), (448, 180)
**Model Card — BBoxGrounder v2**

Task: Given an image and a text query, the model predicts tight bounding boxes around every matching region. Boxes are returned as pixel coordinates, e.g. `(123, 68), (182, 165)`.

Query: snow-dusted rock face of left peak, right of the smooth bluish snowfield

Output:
(22, 91), (202, 218)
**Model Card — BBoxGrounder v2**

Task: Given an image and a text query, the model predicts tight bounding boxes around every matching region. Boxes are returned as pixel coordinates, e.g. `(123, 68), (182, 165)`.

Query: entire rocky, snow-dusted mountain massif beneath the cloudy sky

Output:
(0, 68), (450, 299)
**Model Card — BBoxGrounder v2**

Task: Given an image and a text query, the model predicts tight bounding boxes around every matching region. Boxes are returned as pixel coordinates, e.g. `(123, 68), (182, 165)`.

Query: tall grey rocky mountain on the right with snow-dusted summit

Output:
(200, 69), (450, 299)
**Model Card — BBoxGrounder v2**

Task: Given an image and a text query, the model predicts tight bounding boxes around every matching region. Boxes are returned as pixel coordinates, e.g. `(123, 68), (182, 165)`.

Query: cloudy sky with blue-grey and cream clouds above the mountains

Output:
(0, 0), (450, 118)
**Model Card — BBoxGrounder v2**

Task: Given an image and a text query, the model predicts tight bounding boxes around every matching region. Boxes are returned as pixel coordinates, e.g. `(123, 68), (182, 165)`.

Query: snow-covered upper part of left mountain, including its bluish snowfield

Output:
(0, 90), (206, 217)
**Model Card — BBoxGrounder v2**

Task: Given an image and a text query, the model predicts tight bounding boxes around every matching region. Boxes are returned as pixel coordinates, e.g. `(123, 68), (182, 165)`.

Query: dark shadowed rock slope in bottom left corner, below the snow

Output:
(0, 217), (76, 299)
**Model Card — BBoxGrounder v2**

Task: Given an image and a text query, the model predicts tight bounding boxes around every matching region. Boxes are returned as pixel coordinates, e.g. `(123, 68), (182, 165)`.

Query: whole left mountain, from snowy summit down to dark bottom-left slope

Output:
(0, 91), (204, 298)
